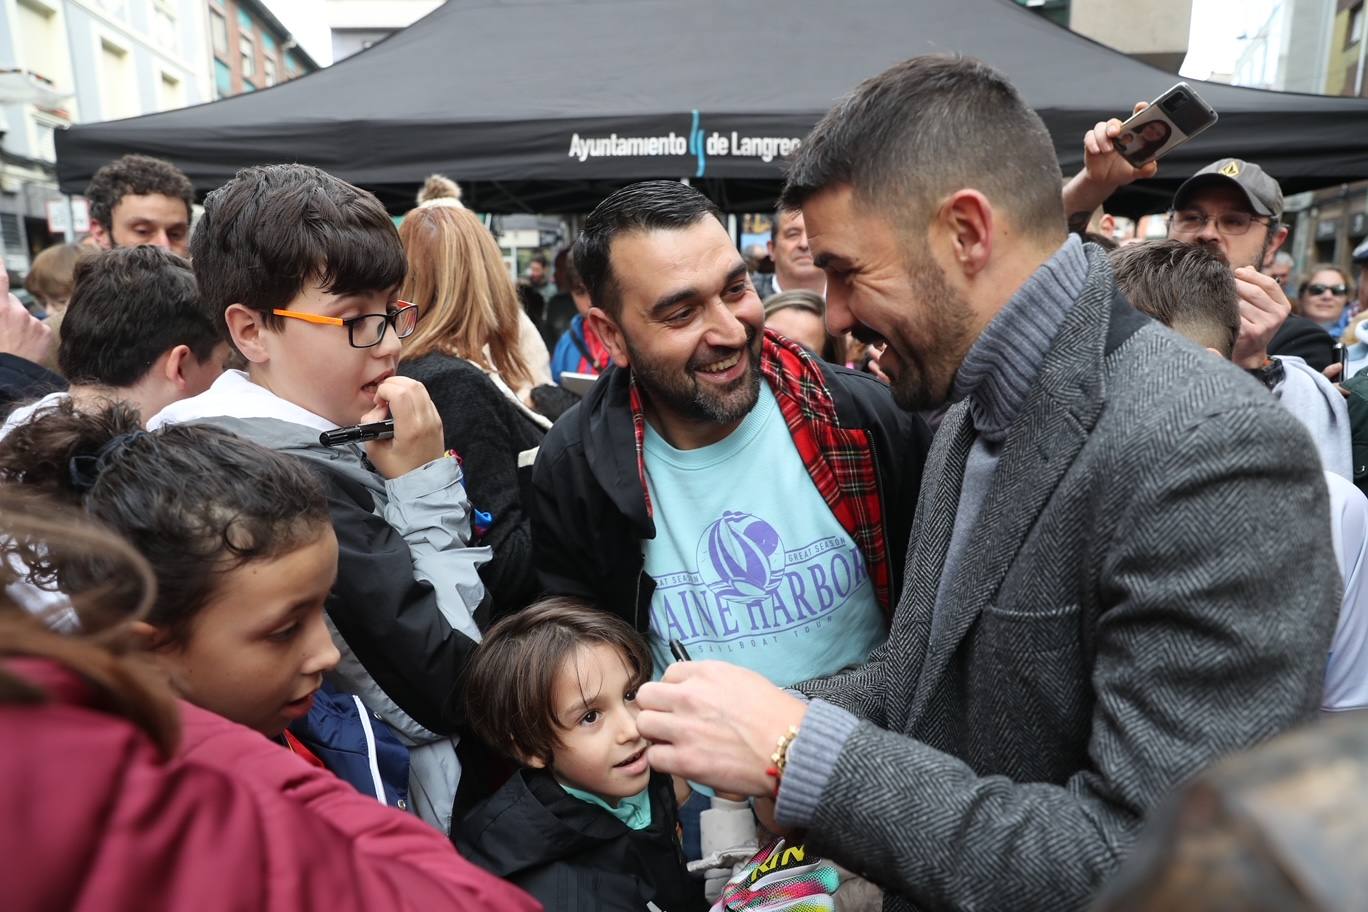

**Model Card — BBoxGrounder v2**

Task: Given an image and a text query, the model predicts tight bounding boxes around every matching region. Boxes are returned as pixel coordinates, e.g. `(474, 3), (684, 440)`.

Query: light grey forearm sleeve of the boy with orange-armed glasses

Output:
(384, 457), (492, 643)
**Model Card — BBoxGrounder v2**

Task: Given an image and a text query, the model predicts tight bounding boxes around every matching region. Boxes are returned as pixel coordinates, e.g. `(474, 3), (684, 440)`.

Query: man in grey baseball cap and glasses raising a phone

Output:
(1064, 125), (1353, 480)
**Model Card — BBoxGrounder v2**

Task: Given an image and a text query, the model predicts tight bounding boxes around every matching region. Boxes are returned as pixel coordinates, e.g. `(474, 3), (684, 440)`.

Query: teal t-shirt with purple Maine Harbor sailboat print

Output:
(644, 383), (885, 686)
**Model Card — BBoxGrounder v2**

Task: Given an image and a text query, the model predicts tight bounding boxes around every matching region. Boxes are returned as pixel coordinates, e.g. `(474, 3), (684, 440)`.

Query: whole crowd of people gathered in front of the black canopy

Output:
(0, 55), (1368, 912)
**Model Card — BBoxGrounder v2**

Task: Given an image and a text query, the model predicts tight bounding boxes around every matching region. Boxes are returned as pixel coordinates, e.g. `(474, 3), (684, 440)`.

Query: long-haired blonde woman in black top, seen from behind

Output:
(399, 205), (551, 614)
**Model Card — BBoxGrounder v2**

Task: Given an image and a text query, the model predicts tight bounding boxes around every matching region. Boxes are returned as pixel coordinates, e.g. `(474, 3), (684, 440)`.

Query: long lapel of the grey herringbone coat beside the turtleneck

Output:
(908, 252), (1112, 725)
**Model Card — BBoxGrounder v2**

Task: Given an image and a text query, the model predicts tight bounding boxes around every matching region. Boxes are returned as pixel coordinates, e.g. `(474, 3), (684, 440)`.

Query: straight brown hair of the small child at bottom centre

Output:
(464, 596), (651, 763)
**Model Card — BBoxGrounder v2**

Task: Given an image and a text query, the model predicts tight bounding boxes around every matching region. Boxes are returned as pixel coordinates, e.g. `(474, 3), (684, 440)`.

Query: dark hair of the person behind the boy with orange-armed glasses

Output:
(57, 245), (222, 388)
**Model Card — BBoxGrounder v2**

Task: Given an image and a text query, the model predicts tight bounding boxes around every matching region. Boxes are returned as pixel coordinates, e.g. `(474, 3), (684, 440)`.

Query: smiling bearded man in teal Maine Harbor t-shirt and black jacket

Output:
(529, 180), (930, 685)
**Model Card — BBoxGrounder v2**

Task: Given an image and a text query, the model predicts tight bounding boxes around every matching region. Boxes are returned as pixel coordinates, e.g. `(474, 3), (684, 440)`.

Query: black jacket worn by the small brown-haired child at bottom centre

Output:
(453, 770), (707, 912)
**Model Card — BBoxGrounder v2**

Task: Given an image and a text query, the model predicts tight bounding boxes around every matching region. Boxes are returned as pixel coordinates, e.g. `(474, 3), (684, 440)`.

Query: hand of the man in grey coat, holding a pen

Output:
(636, 662), (807, 796)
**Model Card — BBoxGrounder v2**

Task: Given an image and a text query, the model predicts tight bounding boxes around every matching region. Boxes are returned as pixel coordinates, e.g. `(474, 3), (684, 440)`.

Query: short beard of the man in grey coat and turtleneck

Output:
(889, 250), (975, 412)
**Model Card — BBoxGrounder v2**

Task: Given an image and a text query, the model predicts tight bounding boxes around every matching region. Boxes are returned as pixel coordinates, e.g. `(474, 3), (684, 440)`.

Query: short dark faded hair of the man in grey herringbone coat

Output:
(780, 55), (1064, 239)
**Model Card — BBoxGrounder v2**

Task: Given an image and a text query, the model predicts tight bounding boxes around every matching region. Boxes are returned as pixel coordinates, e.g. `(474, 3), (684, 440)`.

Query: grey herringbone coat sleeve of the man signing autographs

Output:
(780, 406), (1339, 912)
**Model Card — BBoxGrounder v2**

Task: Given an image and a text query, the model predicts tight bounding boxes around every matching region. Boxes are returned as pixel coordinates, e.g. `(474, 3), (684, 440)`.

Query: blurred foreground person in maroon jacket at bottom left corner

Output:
(0, 475), (536, 912)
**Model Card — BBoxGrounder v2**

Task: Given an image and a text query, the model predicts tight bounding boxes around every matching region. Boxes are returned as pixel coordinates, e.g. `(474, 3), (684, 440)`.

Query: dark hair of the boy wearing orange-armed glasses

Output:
(190, 164), (408, 338)
